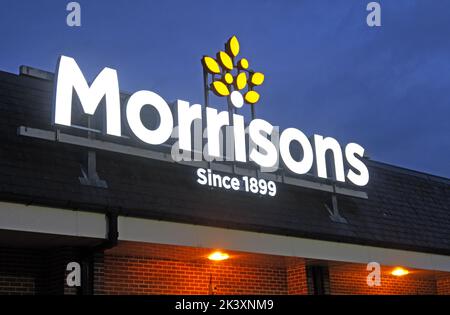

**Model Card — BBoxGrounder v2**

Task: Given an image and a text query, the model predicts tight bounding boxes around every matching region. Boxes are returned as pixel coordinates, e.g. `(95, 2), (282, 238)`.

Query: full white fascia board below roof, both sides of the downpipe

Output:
(0, 202), (450, 272)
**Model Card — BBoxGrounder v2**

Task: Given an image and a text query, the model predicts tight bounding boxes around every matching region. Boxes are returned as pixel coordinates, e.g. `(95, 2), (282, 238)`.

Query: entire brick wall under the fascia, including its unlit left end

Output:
(0, 242), (450, 294)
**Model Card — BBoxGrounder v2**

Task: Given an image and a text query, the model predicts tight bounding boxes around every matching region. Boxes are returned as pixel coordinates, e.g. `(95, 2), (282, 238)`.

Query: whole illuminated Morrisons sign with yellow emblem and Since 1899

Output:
(53, 36), (369, 196)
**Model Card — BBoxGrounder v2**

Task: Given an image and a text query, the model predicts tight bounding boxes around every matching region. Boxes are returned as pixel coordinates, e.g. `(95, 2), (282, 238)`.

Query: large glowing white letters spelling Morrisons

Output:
(53, 56), (369, 186)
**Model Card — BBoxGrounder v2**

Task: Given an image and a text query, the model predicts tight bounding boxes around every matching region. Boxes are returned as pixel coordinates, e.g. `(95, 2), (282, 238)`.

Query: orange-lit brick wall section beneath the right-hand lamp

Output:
(329, 264), (437, 295)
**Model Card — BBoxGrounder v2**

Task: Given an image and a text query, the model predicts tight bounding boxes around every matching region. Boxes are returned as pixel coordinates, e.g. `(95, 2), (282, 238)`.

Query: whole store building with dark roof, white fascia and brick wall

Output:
(0, 67), (450, 294)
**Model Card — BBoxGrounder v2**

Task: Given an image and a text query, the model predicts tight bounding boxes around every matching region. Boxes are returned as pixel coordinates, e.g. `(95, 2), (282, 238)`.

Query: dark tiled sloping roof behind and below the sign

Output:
(0, 72), (450, 255)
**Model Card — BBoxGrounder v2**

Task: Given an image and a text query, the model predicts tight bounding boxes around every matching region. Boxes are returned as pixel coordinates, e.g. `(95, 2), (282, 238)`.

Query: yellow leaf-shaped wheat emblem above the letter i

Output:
(202, 36), (264, 107)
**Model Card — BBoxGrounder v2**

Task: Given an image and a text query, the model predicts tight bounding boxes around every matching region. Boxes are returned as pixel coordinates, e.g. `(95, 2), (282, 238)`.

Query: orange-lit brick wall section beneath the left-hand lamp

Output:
(95, 242), (306, 294)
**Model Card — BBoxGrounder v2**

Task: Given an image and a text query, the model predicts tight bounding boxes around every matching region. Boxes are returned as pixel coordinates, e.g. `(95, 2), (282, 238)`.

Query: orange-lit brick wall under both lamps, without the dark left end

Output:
(94, 242), (450, 294)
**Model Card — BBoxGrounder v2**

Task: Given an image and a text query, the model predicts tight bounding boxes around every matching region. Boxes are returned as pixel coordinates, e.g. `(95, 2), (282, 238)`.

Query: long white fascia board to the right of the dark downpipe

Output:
(119, 217), (450, 271)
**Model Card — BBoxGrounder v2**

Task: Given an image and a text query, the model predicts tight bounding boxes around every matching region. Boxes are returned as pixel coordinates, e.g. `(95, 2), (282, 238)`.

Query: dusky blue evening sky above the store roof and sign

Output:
(0, 0), (450, 177)
